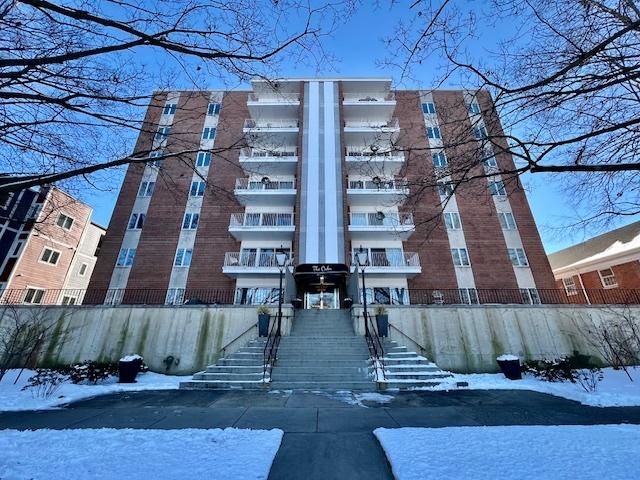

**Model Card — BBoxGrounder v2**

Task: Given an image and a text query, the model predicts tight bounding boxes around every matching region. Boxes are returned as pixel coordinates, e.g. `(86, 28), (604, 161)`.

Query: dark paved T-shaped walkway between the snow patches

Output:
(0, 390), (640, 480)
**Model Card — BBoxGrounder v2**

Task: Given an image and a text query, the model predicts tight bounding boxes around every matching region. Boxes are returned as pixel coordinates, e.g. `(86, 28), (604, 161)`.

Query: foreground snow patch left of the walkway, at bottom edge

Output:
(0, 428), (283, 480)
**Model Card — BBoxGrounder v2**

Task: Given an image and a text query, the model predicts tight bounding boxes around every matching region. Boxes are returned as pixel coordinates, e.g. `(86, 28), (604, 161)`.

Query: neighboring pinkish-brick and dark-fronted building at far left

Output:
(0, 187), (104, 304)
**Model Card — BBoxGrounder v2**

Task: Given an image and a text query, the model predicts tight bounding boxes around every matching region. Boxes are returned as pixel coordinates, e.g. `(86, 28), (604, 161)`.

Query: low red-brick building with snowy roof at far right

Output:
(549, 222), (640, 303)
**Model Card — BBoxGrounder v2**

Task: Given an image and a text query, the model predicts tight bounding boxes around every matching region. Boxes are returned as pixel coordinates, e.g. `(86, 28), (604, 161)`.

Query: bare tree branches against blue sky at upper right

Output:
(381, 0), (640, 232)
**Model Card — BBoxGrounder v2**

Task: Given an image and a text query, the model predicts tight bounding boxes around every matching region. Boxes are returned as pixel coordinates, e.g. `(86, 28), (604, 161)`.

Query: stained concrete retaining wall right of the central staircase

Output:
(353, 305), (640, 373)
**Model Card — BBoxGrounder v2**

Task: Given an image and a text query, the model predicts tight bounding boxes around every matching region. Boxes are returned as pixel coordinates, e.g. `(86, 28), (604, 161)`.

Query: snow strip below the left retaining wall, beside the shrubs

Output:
(0, 369), (191, 411)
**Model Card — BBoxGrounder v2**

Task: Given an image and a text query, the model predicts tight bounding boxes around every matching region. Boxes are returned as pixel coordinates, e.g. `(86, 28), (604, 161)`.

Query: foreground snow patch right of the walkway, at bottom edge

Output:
(373, 425), (640, 480)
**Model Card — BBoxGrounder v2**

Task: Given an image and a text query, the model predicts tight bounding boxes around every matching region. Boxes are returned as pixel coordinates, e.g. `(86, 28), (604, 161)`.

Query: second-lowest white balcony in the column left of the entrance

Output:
(229, 212), (296, 241)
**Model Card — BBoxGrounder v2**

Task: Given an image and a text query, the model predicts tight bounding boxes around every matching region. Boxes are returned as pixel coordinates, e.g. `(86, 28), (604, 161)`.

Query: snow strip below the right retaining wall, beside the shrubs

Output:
(424, 367), (640, 407)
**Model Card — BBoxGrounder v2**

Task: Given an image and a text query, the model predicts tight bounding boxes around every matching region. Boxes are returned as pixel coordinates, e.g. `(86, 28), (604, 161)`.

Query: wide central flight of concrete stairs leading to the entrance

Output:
(271, 310), (375, 390)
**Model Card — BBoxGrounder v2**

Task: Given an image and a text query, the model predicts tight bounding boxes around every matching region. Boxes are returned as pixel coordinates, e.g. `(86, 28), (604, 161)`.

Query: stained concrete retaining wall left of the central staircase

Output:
(0, 305), (292, 374)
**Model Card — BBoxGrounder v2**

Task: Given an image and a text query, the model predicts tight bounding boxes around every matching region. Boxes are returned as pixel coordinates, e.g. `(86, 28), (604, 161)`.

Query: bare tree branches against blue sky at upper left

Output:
(0, 0), (351, 194)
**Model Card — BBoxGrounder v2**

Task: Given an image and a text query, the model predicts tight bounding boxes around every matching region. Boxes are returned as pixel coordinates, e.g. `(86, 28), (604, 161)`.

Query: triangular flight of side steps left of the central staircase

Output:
(180, 338), (266, 390)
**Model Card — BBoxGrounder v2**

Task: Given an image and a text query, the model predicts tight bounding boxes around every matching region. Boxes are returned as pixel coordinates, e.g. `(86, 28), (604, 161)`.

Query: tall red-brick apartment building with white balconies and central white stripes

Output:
(89, 78), (556, 308)
